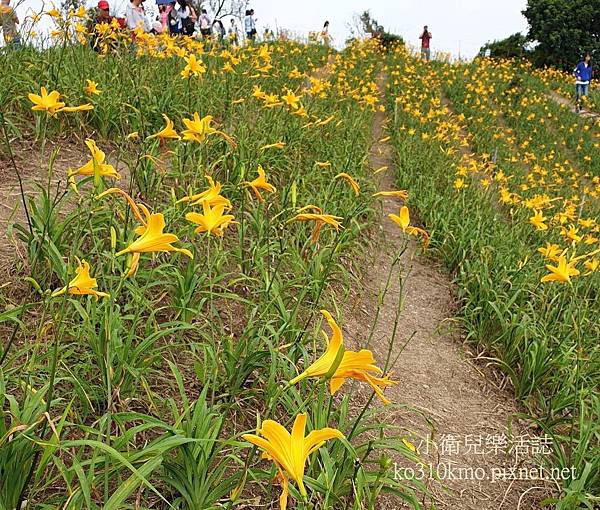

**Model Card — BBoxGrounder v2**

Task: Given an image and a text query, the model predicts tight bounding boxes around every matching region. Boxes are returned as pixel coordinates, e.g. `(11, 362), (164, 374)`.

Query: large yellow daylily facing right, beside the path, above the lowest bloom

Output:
(289, 310), (398, 404)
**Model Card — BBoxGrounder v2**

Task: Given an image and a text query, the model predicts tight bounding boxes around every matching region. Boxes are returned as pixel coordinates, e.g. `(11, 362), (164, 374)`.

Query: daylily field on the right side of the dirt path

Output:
(389, 50), (600, 508)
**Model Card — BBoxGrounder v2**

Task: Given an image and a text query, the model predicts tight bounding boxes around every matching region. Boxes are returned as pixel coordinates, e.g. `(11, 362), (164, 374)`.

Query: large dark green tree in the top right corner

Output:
(523, 0), (600, 69)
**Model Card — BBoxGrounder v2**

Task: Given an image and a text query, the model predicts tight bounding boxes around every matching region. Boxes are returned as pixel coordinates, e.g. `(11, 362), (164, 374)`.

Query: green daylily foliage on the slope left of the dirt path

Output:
(0, 34), (426, 510)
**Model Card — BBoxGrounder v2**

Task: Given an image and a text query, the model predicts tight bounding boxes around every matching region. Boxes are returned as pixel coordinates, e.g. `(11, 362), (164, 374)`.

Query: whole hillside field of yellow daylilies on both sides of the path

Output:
(0, 12), (600, 510)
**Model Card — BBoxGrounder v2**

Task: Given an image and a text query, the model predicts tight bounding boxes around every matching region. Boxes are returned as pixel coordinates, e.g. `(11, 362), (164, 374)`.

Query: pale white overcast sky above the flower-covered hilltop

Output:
(11, 0), (527, 58)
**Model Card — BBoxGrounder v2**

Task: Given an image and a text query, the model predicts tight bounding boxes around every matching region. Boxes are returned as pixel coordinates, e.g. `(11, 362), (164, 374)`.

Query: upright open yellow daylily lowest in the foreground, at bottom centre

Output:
(242, 414), (344, 510)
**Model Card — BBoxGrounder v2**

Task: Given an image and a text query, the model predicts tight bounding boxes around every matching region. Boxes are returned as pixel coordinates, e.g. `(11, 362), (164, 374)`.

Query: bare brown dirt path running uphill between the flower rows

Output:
(345, 76), (548, 510)
